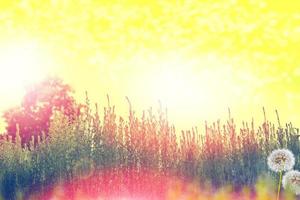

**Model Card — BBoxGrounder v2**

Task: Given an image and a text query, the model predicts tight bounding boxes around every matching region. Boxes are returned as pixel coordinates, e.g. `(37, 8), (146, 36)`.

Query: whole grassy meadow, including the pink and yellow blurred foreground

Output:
(0, 93), (300, 199)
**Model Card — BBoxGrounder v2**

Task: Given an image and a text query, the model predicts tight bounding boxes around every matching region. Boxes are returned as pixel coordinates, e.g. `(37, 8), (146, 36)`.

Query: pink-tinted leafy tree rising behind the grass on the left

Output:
(3, 78), (80, 146)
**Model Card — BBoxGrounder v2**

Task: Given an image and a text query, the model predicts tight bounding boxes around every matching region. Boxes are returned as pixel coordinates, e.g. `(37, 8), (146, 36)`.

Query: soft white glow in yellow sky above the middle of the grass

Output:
(148, 55), (237, 107)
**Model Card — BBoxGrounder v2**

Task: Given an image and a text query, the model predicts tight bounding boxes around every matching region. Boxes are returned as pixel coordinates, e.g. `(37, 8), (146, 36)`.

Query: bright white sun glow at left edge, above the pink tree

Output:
(0, 42), (51, 94)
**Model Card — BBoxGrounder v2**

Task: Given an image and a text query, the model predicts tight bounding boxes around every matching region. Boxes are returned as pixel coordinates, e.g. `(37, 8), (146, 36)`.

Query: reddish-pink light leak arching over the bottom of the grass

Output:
(31, 168), (188, 200)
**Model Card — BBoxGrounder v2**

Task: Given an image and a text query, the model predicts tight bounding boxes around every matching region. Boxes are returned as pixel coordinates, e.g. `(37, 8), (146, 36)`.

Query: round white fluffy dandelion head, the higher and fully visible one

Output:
(268, 149), (295, 172)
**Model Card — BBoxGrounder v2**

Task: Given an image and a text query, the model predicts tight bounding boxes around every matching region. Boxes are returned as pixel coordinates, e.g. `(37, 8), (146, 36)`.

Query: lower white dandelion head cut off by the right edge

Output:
(282, 170), (300, 195)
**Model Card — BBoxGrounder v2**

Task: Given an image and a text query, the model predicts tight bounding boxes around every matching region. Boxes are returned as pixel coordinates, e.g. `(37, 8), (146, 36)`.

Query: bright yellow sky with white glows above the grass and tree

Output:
(0, 0), (300, 132)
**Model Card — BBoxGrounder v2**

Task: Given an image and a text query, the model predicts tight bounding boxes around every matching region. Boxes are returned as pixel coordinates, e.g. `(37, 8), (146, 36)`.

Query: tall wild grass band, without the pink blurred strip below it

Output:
(0, 94), (300, 199)
